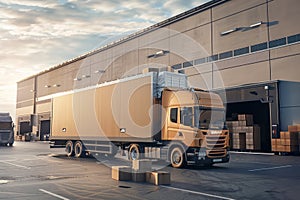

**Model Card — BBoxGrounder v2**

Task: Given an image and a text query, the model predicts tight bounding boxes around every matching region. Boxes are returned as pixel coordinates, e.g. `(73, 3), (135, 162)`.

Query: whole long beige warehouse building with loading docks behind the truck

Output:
(16, 0), (300, 151)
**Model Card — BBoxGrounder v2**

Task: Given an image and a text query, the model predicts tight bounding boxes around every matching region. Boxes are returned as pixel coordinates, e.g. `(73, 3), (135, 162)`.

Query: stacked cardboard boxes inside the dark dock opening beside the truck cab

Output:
(226, 114), (261, 150)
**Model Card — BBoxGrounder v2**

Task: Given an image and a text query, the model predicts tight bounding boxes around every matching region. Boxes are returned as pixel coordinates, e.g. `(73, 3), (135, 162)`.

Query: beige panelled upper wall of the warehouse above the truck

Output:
(17, 0), (300, 142)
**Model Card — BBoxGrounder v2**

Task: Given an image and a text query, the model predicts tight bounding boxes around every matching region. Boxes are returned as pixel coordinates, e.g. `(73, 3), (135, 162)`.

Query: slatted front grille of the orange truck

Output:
(206, 135), (227, 158)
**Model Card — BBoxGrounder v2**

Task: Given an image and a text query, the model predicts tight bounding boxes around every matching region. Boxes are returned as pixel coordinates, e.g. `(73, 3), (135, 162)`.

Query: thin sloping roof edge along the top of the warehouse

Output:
(17, 0), (230, 83)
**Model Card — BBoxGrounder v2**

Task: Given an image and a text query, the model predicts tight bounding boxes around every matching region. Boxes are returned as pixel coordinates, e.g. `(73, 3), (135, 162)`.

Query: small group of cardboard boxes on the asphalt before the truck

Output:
(112, 159), (171, 185)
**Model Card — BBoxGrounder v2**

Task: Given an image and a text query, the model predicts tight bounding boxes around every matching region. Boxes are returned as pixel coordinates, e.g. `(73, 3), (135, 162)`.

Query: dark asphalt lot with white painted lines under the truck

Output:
(0, 142), (300, 200)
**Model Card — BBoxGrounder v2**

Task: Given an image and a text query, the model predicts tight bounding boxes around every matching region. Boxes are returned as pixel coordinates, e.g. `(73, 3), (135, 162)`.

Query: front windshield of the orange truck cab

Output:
(194, 106), (225, 129)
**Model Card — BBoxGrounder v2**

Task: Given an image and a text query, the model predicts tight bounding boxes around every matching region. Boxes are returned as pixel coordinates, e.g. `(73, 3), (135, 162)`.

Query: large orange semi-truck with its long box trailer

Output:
(50, 69), (229, 168)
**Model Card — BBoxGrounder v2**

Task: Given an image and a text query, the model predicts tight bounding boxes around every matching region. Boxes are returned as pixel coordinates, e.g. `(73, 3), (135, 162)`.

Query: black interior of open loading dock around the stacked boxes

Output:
(226, 101), (271, 152)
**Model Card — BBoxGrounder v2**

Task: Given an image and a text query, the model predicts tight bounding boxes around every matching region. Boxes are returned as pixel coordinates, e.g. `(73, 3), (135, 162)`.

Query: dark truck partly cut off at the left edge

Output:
(0, 113), (14, 147)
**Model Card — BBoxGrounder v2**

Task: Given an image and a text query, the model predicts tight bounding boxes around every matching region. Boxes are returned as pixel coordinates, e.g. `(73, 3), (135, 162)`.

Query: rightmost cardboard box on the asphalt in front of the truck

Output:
(146, 171), (171, 185)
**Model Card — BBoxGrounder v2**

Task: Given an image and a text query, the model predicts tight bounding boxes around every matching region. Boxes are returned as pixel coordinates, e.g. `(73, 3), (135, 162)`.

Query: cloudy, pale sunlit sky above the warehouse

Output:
(0, 0), (208, 118)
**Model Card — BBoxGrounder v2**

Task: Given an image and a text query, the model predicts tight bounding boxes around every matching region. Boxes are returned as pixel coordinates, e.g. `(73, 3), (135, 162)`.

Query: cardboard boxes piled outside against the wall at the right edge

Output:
(272, 125), (300, 153)
